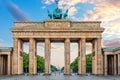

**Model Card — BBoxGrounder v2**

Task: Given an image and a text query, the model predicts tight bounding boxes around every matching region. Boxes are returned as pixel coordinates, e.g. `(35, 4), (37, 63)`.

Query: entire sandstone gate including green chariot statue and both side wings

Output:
(0, 0), (120, 75)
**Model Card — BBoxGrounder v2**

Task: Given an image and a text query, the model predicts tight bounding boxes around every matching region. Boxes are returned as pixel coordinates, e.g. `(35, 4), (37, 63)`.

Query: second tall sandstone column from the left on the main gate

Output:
(29, 38), (37, 75)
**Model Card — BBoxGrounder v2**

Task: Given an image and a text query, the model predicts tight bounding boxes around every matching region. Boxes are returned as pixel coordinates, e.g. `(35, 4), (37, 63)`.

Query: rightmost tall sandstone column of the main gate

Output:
(92, 38), (103, 75)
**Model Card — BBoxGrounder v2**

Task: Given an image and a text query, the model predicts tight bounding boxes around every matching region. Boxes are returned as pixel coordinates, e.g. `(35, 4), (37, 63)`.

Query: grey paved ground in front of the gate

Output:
(0, 74), (120, 80)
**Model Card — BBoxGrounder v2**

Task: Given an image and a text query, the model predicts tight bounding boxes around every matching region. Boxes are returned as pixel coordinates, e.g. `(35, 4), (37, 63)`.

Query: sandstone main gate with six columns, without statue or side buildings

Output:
(11, 19), (104, 75)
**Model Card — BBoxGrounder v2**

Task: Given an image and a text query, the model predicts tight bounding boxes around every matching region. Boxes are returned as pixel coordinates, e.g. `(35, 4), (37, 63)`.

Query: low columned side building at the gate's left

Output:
(0, 47), (12, 75)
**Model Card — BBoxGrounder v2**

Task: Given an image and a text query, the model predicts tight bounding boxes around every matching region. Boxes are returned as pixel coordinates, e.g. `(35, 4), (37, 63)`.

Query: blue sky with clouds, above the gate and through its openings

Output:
(0, 0), (120, 66)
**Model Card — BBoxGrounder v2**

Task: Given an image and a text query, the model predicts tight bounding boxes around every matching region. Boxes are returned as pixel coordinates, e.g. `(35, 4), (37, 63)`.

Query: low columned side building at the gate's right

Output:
(103, 48), (120, 75)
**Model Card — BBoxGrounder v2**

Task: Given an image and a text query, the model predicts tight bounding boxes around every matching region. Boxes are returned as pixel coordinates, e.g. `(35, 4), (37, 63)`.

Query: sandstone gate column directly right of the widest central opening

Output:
(64, 38), (70, 75)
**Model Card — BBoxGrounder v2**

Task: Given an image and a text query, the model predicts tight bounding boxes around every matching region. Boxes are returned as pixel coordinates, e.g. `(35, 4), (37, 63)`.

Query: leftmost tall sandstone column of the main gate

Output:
(12, 38), (23, 75)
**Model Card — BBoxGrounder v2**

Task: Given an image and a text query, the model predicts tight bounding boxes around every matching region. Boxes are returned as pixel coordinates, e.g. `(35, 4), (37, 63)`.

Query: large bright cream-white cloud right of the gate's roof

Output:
(80, 0), (120, 39)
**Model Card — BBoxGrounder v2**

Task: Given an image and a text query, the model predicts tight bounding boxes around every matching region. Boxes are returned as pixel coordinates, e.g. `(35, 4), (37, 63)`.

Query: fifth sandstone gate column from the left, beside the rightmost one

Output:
(78, 38), (86, 75)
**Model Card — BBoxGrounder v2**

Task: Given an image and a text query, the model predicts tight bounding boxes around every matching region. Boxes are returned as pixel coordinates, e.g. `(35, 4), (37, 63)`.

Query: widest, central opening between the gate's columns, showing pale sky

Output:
(51, 42), (65, 75)
